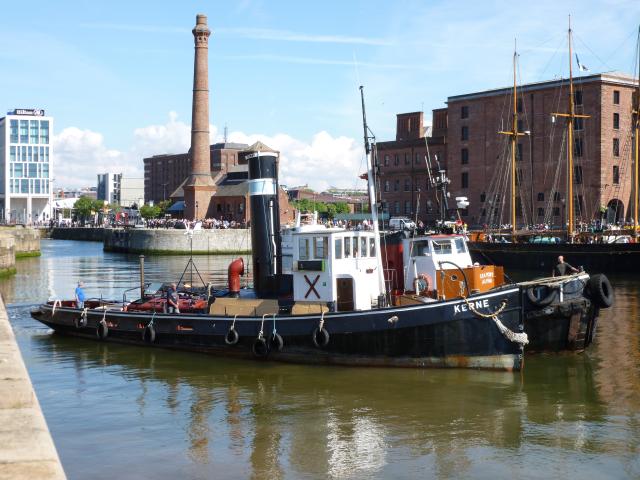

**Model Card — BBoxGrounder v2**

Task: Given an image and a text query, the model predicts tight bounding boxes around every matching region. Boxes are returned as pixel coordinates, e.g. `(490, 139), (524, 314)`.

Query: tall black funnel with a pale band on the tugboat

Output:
(245, 143), (282, 297)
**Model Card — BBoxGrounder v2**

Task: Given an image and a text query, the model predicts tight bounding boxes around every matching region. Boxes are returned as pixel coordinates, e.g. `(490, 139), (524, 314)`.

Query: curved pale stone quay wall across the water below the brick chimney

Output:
(104, 228), (251, 255)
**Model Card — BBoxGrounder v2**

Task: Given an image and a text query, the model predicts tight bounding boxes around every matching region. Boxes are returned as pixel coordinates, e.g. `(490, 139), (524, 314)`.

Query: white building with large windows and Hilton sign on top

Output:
(0, 108), (53, 224)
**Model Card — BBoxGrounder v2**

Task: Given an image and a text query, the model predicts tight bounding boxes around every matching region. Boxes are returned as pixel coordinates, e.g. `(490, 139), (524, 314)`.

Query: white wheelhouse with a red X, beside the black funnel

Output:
(292, 226), (384, 311)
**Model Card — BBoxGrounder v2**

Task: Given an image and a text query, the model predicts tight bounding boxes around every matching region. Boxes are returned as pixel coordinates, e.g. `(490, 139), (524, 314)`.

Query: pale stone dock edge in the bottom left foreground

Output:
(0, 297), (66, 480)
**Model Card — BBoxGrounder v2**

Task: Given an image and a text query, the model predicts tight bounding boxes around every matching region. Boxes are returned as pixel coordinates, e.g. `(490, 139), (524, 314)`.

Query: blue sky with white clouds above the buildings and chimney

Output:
(0, 0), (640, 188)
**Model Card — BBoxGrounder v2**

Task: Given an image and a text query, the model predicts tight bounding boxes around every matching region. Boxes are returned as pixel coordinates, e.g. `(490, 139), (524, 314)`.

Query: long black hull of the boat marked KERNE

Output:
(32, 288), (524, 371)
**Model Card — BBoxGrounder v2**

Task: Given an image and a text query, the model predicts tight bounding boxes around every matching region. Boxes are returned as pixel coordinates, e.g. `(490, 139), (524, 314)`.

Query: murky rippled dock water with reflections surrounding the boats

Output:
(5, 242), (640, 479)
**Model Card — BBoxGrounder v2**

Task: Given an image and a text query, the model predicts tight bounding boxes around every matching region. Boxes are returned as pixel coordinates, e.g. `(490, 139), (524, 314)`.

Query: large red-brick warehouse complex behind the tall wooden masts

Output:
(378, 73), (637, 226)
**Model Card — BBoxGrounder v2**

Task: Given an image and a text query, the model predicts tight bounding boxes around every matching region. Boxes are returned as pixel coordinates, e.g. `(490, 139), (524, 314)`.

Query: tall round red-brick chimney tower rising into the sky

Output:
(184, 14), (215, 220)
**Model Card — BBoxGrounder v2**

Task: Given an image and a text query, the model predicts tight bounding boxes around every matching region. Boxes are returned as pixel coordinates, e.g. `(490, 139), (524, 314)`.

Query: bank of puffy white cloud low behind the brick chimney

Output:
(53, 112), (366, 191)
